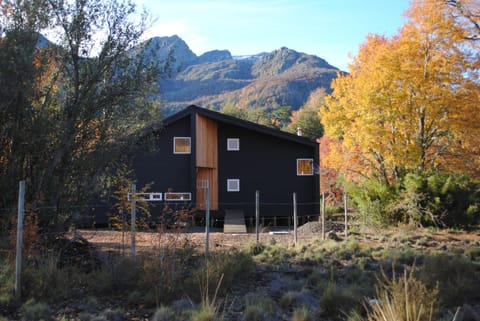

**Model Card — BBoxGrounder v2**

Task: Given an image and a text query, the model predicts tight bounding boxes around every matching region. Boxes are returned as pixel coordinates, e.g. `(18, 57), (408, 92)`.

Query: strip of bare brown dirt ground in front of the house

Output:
(77, 222), (480, 253)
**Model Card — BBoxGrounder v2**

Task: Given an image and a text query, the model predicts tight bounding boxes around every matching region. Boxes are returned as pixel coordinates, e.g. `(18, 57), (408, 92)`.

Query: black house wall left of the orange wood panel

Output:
(133, 116), (194, 208)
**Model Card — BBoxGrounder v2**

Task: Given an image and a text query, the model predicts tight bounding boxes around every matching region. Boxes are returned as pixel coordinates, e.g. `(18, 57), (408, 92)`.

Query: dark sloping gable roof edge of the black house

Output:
(156, 105), (317, 146)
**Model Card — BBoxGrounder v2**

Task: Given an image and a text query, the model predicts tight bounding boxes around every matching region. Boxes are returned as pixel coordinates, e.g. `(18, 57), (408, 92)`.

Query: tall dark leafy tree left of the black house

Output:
(0, 0), (160, 228)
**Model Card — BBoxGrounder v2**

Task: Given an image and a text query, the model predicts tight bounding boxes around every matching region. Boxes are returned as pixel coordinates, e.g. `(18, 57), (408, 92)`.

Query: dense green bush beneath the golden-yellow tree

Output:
(348, 171), (480, 228)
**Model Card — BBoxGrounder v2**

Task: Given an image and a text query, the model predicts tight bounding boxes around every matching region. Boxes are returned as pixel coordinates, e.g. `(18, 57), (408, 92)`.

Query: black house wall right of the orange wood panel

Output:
(218, 123), (319, 216)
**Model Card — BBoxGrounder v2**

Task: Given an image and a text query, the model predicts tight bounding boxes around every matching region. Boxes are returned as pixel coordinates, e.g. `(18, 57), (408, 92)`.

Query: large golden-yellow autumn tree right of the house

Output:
(321, 0), (480, 185)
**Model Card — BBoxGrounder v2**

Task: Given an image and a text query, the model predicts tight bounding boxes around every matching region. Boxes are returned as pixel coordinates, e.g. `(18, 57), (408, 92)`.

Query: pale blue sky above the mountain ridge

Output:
(136, 0), (410, 70)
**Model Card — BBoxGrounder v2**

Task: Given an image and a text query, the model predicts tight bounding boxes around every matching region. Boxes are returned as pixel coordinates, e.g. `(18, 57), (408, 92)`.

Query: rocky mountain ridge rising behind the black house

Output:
(136, 36), (340, 111)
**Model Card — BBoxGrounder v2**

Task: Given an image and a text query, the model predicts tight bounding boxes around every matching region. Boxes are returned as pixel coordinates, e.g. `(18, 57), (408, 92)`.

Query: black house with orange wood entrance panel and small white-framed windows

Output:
(134, 105), (319, 222)
